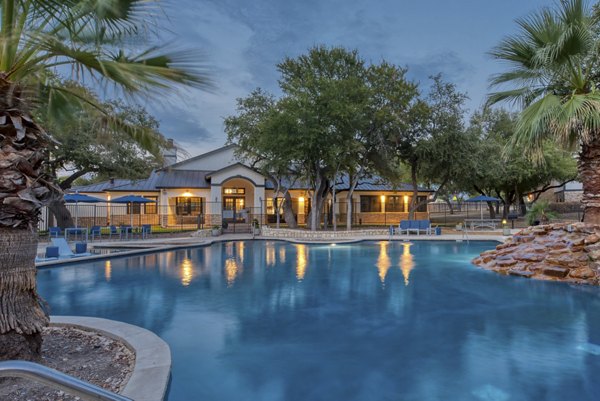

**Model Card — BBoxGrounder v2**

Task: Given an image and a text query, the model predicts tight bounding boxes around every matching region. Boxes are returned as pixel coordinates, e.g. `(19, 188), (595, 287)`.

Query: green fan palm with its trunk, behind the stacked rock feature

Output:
(488, 0), (600, 224)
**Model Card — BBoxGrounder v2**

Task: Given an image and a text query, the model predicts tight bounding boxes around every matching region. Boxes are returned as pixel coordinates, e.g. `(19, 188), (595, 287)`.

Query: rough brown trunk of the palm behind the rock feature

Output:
(578, 134), (600, 224)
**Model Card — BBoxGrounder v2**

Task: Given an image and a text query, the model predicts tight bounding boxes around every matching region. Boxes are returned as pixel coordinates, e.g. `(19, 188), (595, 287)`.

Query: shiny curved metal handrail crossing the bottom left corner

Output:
(0, 361), (132, 401)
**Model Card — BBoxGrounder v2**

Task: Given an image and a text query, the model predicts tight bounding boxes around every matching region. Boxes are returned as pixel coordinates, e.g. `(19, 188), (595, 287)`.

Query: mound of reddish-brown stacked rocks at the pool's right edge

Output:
(473, 223), (600, 285)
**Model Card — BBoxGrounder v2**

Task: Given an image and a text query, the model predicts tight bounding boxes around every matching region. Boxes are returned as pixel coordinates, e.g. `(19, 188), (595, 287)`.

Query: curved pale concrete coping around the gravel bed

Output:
(50, 316), (172, 401)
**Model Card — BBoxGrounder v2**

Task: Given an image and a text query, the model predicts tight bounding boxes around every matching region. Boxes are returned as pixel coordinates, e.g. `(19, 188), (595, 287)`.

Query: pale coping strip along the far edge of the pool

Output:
(35, 234), (502, 269)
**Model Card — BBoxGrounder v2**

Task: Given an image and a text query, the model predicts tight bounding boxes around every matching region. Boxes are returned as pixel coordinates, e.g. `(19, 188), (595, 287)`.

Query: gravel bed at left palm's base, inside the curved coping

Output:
(0, 327), (135, 401)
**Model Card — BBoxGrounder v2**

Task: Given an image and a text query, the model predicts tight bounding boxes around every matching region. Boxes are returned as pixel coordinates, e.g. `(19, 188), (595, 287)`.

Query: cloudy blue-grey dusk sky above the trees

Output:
(146, 0), (554, 156)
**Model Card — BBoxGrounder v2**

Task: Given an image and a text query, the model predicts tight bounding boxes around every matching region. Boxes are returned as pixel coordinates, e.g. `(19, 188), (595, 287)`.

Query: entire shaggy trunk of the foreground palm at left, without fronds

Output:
(0, 73), (61, 360)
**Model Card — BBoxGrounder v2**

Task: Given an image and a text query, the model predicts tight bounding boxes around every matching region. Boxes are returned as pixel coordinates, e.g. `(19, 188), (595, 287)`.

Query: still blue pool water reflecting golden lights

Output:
(38, 241), (600, 401)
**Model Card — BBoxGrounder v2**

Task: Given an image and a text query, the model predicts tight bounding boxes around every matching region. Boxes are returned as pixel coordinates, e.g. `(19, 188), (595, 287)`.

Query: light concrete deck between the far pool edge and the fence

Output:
(36, 230), (506, 268)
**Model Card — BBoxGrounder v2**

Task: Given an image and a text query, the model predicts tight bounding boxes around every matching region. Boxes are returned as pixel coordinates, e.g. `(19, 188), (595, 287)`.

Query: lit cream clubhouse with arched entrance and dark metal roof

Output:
(71, 145), (432, 227)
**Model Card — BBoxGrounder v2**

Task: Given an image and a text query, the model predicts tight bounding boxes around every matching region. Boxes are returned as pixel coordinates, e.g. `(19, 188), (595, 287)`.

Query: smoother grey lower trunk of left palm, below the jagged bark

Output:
(0, 227), (48, 360)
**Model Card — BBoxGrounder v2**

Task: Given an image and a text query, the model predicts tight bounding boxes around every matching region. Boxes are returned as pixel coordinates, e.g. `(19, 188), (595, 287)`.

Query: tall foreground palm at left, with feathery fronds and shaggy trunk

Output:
(0, 0), (207, 360)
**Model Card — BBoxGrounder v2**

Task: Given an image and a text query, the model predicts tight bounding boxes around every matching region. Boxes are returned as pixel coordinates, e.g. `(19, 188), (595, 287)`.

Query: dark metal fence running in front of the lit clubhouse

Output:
(38, 199), (428, 233)
